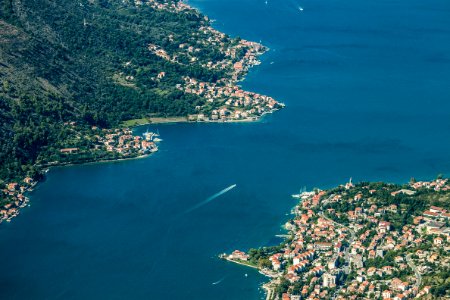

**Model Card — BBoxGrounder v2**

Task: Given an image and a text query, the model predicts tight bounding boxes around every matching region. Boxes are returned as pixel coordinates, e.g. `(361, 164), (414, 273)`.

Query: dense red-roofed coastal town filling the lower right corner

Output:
(225, 178), (450, 300)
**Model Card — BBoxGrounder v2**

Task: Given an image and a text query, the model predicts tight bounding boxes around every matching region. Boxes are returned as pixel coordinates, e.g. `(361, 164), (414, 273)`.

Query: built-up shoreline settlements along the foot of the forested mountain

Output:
(0, 0), (284, 223)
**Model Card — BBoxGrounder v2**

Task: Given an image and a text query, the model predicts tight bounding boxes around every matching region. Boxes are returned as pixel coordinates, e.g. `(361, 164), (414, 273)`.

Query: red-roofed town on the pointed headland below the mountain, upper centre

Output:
(144, 0), (284, 122)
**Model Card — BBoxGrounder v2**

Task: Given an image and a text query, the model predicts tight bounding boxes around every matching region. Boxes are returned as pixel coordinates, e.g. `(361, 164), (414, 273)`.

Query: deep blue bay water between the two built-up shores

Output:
(0, 0), (450, 299)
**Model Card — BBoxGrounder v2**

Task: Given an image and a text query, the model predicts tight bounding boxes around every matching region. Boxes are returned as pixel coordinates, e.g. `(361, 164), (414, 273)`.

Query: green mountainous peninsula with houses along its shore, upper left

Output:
(0, 0), (284, 222)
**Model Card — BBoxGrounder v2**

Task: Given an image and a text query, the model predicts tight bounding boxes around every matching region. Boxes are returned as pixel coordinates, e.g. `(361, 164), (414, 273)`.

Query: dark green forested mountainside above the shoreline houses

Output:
(0, 0), (239, 184)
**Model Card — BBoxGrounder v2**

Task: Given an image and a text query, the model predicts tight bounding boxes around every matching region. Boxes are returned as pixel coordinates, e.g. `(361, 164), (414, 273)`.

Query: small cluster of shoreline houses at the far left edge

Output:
(0, 177), (36, 223)
